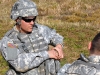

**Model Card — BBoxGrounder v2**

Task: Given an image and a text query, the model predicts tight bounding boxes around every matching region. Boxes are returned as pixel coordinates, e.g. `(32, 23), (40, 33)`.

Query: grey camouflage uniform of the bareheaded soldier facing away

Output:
(57, 55), (100, 75)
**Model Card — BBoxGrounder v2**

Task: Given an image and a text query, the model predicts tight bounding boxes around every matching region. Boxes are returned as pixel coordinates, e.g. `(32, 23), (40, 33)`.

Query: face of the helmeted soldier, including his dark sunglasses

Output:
(20, 17), (36, 33)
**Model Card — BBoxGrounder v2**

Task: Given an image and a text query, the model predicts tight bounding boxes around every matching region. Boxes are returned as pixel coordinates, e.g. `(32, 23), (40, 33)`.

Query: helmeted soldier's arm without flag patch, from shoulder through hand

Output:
(39, 26), (63, 59)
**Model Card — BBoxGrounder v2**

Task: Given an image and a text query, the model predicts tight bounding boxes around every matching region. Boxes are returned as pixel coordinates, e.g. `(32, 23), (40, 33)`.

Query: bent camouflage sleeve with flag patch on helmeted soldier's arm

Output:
(0, 37), (49, 72)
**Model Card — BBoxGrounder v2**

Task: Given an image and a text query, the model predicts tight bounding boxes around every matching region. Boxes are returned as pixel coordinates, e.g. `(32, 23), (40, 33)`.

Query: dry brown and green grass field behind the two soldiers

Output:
(0, 0), (100, 75)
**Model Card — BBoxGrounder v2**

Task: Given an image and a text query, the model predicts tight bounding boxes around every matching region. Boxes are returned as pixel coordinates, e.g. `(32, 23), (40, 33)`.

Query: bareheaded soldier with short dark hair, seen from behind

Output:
(57, 33), (100, 75)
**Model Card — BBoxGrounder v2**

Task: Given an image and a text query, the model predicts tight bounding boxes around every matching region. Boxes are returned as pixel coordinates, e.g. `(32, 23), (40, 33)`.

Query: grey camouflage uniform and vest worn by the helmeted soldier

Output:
(0, 23), (63, 75)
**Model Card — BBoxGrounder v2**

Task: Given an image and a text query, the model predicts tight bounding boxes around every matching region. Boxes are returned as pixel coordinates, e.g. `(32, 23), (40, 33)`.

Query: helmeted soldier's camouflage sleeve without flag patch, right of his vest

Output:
(39, 25), (63, 46)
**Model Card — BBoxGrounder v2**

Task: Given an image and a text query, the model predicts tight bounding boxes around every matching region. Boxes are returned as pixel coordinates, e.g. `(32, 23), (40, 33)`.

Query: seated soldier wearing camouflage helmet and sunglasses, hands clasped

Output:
(0, 0), (63, 75)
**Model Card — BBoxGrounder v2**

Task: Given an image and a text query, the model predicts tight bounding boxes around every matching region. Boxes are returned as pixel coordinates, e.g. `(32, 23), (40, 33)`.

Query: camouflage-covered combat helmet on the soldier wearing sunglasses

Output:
(10, 0), (38, 20)
